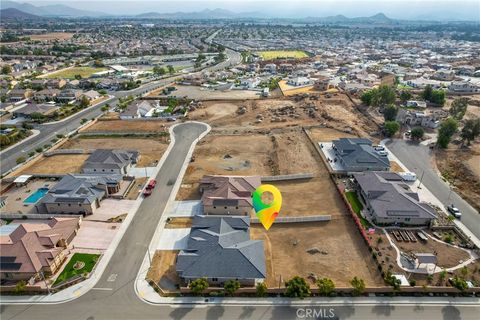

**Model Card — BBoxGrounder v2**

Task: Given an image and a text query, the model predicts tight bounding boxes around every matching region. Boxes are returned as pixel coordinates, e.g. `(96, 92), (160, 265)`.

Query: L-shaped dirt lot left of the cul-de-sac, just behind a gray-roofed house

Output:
(62, 137), (168, 167)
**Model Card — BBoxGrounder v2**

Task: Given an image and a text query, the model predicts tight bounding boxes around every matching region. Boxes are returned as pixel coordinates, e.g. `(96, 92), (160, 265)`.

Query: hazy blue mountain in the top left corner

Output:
(0, 0), (107, 18)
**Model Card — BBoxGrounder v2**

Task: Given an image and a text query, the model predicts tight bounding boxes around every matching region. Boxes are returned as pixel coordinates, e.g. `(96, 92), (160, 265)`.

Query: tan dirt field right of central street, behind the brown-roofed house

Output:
(177, 134), (273, 200)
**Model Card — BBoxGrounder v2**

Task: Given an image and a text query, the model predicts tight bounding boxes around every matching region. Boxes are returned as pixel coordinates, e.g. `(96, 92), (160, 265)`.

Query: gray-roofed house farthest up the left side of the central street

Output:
(82, 149), (139, 174)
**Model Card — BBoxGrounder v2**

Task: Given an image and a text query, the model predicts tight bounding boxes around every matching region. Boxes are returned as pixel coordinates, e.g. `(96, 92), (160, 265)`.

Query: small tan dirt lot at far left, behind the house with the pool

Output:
(19, 154), (89, 175)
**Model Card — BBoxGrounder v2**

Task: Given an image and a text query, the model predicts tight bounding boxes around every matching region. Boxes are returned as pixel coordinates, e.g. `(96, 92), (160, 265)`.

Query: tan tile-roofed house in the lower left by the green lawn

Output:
(0, 217), (81, 282)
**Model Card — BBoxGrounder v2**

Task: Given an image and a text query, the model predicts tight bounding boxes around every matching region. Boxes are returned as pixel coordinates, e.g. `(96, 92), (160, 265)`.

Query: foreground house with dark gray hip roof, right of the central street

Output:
(176, 216), (267, 287)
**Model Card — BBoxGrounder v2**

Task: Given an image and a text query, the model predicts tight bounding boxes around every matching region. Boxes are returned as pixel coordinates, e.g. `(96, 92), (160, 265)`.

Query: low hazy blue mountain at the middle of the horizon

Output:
(135, 8), (264, 20)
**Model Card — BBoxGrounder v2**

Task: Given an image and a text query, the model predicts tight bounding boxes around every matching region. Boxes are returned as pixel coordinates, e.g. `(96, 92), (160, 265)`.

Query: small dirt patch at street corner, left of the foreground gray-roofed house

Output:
(147, 250), (180, 291)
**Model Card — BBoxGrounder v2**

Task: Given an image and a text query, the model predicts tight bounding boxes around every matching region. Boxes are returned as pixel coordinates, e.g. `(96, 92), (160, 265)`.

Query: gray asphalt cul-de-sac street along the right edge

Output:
(387, 139), (480, 238)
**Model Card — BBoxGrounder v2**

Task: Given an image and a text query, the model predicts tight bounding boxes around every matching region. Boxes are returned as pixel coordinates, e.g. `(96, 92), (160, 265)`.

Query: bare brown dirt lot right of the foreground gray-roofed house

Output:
(250, 220), (383, 287)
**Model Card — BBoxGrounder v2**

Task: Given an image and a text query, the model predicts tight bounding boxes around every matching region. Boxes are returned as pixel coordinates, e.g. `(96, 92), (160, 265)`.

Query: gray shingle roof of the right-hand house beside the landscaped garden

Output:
(353, 172), (436, 219)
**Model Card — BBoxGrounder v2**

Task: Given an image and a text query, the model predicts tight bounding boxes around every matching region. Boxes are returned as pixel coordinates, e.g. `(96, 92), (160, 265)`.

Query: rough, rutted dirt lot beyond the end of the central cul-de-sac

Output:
(188, 94), (378, 136)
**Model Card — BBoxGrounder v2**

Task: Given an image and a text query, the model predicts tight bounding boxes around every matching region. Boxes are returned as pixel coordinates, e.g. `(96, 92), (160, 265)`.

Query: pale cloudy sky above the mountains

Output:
(13, 0), (480, 21)
